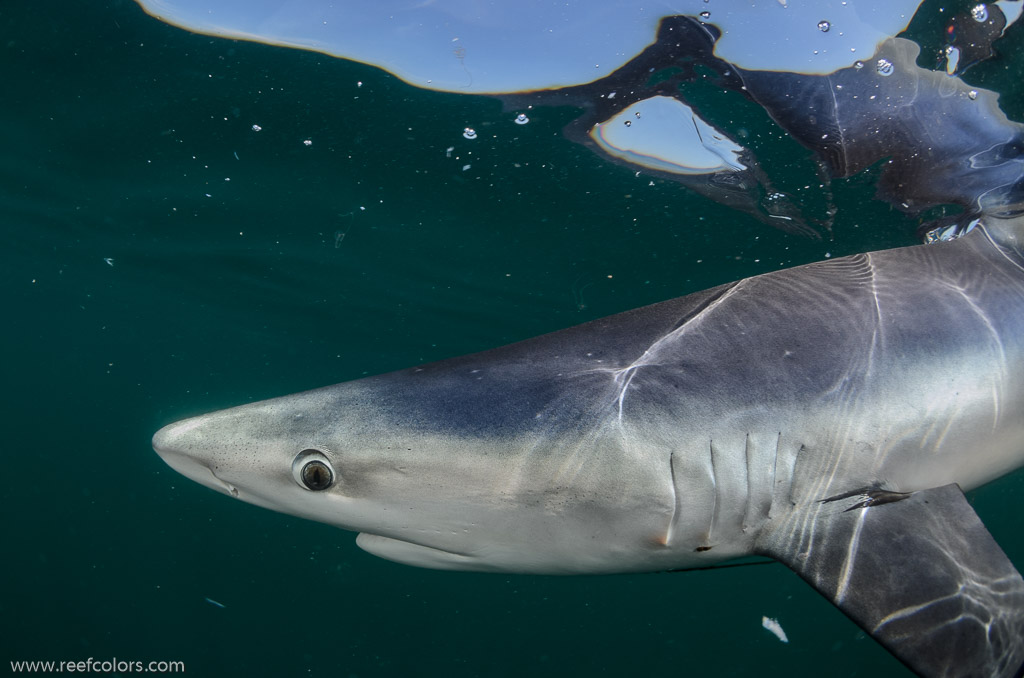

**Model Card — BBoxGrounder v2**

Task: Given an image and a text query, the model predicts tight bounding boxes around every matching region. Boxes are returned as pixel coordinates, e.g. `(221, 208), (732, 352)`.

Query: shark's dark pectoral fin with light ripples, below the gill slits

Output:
(758, 484), (1024, 676)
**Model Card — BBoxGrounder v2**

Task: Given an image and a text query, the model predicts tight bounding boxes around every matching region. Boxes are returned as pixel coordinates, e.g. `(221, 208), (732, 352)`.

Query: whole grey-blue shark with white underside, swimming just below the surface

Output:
(154, 218), (1024, 676)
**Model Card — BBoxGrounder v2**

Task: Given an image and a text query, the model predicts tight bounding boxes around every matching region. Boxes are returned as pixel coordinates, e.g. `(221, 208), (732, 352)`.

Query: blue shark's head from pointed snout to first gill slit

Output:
(153, 337), (704, 574)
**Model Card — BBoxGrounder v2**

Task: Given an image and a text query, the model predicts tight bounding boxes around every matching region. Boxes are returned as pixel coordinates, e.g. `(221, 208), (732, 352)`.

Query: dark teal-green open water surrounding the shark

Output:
(0, 0), (1024, 678)
